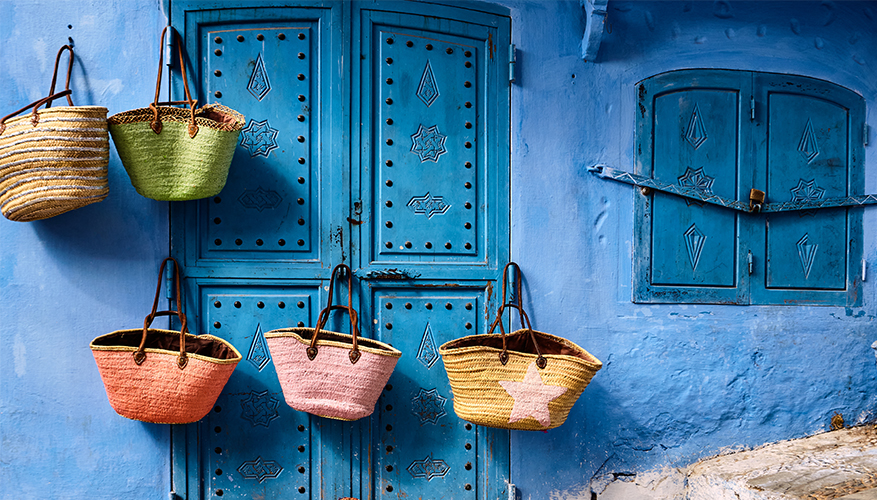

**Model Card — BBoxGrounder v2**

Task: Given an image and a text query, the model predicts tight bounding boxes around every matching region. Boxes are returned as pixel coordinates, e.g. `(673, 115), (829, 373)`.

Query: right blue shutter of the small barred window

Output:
(753, 74), (864, 305)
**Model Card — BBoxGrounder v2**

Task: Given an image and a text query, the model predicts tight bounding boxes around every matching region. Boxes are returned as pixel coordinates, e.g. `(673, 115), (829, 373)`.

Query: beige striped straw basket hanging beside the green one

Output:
(0, 45), (110, 222)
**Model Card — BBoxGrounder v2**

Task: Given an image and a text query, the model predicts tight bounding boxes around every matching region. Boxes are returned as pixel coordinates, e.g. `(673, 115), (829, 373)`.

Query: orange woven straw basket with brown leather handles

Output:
(91, 259), (241, 424)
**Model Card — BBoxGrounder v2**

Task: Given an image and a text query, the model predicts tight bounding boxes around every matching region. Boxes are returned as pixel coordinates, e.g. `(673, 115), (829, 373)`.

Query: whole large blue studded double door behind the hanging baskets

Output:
(172, 1), (509, 499)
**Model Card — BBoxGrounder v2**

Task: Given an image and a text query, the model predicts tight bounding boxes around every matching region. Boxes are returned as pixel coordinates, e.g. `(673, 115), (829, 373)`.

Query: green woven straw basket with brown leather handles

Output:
(109, 27), (244, 201)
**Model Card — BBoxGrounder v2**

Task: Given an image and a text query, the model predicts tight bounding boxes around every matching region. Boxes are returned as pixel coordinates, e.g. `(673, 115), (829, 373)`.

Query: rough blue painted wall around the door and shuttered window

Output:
(0, 0), (877, 499)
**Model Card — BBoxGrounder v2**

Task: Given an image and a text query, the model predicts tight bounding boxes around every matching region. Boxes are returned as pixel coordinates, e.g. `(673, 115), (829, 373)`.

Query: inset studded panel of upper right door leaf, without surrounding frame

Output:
(372, 27), (484, 261)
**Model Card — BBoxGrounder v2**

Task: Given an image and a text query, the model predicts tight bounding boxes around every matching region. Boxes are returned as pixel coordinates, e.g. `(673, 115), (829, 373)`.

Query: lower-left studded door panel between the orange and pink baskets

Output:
(197, 283), (320, 499)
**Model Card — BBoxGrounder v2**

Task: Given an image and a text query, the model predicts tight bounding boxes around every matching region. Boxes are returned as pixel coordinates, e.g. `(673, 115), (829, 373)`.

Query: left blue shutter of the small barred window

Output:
(634, 71), (751, 303)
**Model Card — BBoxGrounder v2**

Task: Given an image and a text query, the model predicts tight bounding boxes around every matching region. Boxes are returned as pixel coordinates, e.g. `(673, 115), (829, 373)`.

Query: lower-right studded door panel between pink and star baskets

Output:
(373, 288), (487, 499)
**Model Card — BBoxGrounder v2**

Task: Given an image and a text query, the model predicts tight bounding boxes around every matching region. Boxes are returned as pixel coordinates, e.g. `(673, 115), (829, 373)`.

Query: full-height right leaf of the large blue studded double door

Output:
(353, 3), (510, 499)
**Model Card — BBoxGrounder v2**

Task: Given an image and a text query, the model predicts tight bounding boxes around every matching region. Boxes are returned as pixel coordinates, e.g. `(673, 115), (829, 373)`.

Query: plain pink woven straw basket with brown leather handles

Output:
(265, 264), (402, 420)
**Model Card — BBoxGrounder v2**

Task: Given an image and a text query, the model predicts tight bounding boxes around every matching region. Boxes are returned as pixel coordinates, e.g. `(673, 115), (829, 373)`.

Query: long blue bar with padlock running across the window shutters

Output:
(588, 165), (877, 213)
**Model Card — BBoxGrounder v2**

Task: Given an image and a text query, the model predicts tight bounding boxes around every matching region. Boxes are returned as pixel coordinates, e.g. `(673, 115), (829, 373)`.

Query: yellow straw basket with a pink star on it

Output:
(439, 262), (603, 431)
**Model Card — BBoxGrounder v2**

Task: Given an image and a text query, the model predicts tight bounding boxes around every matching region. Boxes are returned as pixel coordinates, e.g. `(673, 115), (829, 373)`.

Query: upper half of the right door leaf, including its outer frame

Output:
(352, 2), (510, 280)
